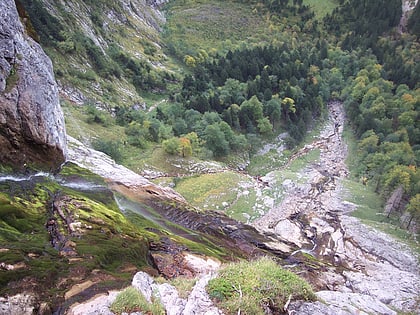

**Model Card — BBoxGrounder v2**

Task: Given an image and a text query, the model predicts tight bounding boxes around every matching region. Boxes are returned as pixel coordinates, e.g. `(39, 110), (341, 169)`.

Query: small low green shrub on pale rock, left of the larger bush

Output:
(110, 287), (165, 315)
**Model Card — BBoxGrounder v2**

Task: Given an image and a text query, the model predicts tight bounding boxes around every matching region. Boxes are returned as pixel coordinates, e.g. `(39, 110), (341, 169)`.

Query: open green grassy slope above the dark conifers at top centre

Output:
(165, 0), (268, 56)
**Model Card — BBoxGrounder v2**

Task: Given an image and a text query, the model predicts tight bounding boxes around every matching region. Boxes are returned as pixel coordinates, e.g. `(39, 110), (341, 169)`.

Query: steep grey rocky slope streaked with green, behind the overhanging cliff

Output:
(17, 0), (172, 109)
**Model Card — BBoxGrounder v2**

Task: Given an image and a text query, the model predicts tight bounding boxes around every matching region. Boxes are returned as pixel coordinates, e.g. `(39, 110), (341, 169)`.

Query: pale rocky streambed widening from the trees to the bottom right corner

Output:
(253, 102), (420, 314)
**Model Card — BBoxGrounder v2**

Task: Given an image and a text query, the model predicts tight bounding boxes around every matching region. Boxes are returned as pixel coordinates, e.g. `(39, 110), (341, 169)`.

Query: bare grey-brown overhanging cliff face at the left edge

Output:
(0, 0), (66, 168)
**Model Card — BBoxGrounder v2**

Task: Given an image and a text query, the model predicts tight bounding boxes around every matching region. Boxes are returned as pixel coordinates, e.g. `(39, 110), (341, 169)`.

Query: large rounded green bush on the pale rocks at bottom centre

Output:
(207, 257), (315, 315)
